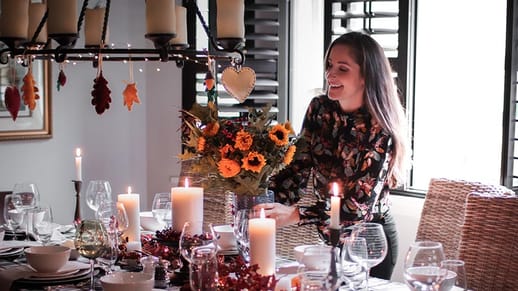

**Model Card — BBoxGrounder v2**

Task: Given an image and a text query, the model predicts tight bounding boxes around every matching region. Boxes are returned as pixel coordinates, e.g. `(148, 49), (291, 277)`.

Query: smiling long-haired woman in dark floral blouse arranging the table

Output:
(257, 32), (407, 279)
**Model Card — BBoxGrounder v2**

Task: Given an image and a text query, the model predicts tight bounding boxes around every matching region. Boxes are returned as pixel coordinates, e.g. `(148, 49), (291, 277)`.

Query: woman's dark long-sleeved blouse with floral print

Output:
(270, 95), (391, 239)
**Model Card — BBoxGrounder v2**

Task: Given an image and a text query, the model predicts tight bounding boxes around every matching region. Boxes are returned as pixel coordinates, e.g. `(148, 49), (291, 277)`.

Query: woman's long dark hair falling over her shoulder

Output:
(325, 32), (408, 187)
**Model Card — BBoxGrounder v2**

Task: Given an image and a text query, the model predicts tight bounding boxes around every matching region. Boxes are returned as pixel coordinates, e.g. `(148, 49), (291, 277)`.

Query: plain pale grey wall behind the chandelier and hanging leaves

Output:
(0, 0), (181, 223)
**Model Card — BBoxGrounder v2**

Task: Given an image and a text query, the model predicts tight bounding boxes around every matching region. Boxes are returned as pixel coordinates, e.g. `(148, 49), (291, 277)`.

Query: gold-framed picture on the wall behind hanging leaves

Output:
(0, 60), (52, 141)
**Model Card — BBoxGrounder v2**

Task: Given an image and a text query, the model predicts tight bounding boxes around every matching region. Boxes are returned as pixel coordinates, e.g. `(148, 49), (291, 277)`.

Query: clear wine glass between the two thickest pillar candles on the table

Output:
(180, 221), (218, 263)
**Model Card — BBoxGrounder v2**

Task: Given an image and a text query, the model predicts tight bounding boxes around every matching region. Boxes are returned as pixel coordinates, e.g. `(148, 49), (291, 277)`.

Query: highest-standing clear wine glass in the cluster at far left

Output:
(11, 183), (40, 240)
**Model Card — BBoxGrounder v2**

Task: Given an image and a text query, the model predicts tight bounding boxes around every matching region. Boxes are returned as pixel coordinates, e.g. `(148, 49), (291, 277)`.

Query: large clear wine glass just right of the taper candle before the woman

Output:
(350, 222), (388, 290)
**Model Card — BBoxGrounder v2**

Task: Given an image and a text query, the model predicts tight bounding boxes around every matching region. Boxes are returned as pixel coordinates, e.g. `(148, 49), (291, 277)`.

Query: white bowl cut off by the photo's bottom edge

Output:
(100, 272), (155, 291)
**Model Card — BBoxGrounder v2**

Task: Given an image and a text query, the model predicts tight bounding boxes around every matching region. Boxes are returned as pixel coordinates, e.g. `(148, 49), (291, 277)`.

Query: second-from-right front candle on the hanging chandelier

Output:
(146, 0), (176, 34)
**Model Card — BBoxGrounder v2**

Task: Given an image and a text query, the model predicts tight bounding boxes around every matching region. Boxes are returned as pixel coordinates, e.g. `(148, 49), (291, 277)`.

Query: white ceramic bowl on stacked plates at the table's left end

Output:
(25, 246), (70, 273)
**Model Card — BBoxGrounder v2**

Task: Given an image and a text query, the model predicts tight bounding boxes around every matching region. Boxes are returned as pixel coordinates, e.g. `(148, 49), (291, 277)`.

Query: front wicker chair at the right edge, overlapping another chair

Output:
(459, 193), (518, 291)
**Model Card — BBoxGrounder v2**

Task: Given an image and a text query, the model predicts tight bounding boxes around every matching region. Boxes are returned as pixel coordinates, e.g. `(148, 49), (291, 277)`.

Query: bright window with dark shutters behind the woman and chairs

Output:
(325, 0), (518, 191)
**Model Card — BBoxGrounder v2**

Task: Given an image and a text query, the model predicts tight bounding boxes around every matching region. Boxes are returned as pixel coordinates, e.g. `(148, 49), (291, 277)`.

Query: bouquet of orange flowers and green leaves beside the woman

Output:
(179, 101), (296, 195)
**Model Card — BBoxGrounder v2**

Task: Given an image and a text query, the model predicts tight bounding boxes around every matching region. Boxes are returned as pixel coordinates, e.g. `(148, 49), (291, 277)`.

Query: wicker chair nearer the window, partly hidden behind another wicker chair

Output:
(416, 178), (514, 259)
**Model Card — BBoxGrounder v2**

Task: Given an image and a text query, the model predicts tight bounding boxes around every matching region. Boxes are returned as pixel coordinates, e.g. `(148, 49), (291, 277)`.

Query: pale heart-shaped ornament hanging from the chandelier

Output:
(221, 67), (255, 103)
